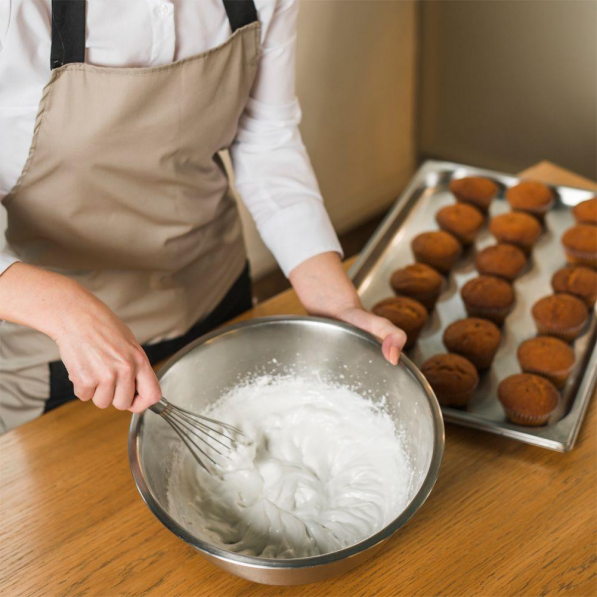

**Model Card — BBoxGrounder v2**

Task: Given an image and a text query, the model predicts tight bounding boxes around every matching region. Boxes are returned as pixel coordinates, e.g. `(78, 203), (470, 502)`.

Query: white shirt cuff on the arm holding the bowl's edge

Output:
(259, 198), (344, 277)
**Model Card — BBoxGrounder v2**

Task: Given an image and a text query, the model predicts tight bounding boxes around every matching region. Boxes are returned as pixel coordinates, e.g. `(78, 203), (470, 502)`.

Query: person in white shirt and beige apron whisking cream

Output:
(0, 0), (405, 432)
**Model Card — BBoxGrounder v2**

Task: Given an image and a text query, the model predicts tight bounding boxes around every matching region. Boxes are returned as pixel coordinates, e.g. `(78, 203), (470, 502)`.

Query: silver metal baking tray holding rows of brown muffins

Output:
(349, 161), (597, 452)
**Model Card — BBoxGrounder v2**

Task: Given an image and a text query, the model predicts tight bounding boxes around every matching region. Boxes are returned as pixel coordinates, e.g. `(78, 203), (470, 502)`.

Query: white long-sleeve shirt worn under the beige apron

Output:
(0, 0), (341, 275)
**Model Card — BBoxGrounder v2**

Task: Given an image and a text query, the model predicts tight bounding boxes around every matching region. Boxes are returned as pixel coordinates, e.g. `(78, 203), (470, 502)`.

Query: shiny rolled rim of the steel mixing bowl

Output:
(128, 315), (445, 570)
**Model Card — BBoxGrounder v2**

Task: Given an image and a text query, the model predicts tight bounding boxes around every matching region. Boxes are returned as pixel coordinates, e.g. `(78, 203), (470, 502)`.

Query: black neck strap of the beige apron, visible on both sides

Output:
(50, 0), (257, 69)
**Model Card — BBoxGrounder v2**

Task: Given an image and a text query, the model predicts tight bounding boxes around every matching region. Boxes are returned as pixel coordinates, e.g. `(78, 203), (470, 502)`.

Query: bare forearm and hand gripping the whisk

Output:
(0, 263), (162, 412)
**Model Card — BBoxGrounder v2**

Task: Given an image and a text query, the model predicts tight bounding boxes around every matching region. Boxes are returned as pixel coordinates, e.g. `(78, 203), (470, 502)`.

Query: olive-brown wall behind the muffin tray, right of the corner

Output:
(418, 0), (597, 179)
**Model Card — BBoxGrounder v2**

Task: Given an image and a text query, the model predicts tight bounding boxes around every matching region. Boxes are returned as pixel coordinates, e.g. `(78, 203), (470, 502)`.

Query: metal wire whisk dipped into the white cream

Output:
(149, 397), (250, 473)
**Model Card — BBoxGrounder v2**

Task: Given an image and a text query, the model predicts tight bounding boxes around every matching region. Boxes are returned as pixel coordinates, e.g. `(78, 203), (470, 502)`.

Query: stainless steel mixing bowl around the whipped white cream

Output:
(129, 317), (444, 585)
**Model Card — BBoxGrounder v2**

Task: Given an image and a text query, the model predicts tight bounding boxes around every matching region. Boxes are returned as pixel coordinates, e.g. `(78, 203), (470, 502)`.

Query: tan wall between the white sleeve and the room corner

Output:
(243, 0), (416, 275)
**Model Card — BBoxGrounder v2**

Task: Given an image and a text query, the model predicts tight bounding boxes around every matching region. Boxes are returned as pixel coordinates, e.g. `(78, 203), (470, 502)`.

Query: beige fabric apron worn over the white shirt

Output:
(0, 7), (260, 431)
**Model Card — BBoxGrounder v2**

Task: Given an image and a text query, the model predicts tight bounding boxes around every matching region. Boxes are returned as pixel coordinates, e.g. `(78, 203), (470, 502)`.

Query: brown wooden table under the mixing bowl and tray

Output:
(0, 163), (597, 597)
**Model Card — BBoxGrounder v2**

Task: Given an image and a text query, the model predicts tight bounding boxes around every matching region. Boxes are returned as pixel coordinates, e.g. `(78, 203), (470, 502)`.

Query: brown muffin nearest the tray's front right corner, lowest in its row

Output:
(498, 373), (559, 426)
